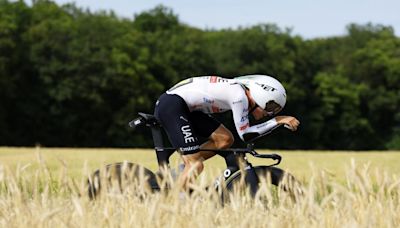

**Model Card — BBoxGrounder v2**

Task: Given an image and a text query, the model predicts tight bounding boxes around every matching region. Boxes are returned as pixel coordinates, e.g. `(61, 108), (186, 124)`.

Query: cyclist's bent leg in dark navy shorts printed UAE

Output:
(154, 97), (233, 190)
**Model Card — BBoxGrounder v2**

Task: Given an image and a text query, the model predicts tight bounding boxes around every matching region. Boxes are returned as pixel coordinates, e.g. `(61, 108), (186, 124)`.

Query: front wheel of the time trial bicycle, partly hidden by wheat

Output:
(222, 166), (303, 202)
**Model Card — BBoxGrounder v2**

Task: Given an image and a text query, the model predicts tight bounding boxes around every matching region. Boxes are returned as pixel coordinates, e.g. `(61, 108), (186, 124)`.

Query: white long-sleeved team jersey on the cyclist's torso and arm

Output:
(167, 76), (278, 140)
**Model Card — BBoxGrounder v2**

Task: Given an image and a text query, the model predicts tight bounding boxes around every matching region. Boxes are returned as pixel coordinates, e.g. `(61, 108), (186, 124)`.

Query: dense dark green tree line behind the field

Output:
(0, 0), (400, 150)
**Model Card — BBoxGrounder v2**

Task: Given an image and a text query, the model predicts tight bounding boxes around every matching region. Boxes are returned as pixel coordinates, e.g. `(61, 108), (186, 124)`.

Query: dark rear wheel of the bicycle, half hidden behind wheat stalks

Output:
(87, 162), (160, 199)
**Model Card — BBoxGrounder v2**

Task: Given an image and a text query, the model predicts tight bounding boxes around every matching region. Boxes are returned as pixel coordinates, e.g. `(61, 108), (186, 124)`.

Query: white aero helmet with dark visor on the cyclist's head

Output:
(235, 75), (286, 114)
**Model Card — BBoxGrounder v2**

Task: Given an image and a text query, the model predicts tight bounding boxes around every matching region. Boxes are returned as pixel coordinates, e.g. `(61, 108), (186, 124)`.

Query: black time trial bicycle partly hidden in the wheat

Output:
(88, 112), (302, 201)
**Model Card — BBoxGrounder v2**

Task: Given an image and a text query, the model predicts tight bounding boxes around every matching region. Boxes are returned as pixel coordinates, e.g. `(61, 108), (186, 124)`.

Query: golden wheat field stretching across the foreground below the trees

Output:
(0, 147), (400, 227)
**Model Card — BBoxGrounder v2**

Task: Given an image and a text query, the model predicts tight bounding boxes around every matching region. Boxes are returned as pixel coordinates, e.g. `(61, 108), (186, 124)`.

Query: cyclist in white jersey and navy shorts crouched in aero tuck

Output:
(154, 75), (300, 188)
